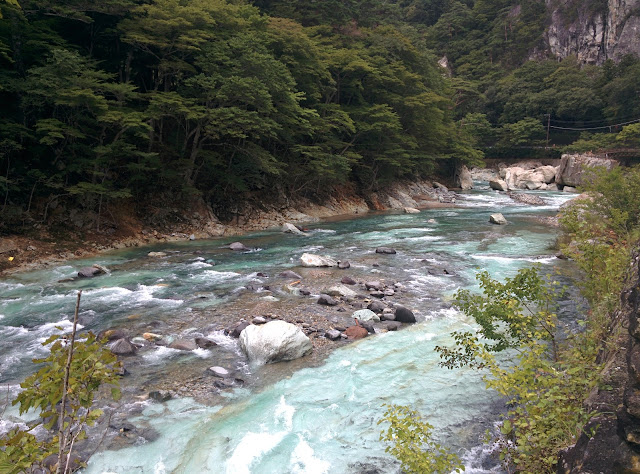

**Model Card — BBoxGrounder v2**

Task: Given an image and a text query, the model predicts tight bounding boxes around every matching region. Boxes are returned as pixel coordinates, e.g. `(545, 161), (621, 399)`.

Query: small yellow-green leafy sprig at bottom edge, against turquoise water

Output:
(378, 405), (464, 474)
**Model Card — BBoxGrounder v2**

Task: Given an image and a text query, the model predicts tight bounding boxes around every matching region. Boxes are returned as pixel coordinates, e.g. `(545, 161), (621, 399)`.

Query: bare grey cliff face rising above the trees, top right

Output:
(545, 0), (640, 64)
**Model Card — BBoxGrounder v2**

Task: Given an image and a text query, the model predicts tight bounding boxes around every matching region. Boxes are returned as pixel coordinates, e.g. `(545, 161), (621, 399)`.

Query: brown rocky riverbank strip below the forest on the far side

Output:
(0, 180), (455, 276)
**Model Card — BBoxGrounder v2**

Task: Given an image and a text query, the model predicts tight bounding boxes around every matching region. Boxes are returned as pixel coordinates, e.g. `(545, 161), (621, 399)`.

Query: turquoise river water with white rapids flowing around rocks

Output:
(0, 183), (572, 474)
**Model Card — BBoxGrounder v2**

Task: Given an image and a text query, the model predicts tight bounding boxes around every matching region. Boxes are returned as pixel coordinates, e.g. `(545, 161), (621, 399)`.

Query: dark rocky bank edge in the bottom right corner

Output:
(558, 248), (640, 474)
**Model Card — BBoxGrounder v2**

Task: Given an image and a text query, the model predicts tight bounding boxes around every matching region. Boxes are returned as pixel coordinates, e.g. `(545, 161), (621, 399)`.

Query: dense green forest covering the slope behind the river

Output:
(0, 0), (640, 231)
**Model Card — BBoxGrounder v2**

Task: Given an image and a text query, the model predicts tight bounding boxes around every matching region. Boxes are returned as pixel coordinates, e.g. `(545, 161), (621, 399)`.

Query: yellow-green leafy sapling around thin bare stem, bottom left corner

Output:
(0, 324), (120, 474)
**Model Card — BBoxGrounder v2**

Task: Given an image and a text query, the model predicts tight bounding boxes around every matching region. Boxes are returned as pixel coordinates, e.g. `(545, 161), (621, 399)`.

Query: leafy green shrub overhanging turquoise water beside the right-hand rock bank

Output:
(436, 268), (597, 473)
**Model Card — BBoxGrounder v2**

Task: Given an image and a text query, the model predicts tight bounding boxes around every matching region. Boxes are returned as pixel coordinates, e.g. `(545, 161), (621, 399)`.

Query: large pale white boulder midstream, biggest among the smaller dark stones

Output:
(240, 321), (313, 365)
